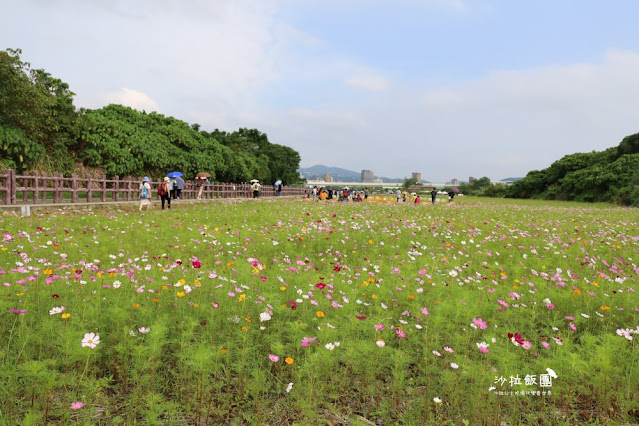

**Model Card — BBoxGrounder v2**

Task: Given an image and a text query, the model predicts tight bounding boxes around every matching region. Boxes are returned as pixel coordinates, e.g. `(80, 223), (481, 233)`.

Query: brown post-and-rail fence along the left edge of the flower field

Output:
(0, 170), (306, 205)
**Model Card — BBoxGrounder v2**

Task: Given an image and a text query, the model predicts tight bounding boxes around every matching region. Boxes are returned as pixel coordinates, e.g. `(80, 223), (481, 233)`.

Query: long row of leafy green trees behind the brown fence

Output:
(0, 49), (301, 185)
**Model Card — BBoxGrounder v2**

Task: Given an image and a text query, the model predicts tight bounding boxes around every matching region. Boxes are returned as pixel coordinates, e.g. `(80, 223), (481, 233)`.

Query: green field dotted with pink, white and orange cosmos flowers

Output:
(0, 197), (639, 425)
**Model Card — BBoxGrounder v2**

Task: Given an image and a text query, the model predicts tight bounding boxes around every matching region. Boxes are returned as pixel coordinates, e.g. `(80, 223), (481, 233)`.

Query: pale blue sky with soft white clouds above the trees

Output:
(0, 0), (639, 182)
